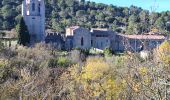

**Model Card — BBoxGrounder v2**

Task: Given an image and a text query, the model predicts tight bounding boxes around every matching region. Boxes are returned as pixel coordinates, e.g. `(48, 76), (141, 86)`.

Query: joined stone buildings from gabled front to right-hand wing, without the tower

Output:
(65, 26), (166, 52)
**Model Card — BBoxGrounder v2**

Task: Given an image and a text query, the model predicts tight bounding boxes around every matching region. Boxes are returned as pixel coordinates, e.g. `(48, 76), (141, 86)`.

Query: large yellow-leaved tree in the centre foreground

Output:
(59, 57), (126, 100)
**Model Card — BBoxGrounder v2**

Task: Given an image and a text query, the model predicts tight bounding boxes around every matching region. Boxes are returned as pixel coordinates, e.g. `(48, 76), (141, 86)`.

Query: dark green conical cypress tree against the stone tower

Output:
(16, 18), (30, 46)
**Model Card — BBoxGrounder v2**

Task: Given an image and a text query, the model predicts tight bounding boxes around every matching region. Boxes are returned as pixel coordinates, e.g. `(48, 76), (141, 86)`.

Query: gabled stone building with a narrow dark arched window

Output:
(65, 26), (91, 50)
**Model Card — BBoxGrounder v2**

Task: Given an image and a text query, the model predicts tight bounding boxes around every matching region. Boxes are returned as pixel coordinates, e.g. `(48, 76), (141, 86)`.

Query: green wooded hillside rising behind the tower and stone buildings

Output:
(0, 0), (170, 34)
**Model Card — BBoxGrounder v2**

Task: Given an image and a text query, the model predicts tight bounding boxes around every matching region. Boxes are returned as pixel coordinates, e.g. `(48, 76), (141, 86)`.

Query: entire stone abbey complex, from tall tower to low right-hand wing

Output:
(22, 0), (166, 52)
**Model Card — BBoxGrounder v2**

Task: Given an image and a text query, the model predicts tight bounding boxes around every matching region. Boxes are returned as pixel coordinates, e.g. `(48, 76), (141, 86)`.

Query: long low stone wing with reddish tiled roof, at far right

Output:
(112, 34), (166, 52)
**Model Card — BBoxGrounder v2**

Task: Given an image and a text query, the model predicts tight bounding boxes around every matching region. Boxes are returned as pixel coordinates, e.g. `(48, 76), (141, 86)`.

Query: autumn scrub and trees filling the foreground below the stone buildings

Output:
(0, 41), (170, 100)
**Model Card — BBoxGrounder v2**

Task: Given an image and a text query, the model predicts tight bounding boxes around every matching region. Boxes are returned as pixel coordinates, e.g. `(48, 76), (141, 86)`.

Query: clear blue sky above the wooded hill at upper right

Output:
(89, 0), (170, 12)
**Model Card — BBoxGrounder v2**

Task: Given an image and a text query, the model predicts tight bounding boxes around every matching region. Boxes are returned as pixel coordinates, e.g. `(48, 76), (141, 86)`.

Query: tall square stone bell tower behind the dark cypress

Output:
(22, 0), (45, 44)
